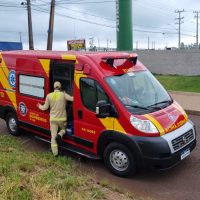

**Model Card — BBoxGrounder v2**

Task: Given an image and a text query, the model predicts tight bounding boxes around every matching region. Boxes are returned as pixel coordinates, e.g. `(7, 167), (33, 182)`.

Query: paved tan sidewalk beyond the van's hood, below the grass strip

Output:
(169, 91), (200, 115)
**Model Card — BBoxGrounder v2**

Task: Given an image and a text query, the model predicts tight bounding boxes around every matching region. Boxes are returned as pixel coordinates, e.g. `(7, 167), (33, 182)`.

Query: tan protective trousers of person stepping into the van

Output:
(50, 121), (66, 156)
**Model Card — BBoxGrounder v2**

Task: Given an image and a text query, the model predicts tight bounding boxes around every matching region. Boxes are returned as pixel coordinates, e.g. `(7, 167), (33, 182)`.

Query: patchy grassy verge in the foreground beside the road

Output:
(0, 135), (141, 200)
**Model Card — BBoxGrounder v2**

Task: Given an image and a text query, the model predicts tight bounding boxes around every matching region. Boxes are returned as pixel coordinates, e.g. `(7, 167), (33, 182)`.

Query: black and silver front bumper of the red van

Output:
(132, 121), (196, 170)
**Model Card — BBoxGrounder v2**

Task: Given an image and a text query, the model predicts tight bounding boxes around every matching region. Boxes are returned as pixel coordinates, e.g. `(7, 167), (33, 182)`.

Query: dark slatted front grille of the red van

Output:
(172, 129), (194, 151)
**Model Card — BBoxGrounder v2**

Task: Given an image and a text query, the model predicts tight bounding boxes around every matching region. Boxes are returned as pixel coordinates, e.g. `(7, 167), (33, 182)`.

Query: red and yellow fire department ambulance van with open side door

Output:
(0, 51), (196, 176)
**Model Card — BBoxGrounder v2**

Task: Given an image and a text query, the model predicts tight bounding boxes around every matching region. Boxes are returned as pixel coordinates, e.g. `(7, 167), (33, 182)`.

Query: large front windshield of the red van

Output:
(106, 71), (172, 114)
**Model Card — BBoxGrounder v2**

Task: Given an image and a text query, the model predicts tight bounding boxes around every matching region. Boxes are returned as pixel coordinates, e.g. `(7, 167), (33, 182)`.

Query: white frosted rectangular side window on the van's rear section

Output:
(19, 75), (45, 98)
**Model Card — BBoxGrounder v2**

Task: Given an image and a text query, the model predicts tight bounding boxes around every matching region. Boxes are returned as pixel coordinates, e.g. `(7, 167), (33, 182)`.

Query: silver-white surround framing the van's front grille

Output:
(161, 121), (195, 153)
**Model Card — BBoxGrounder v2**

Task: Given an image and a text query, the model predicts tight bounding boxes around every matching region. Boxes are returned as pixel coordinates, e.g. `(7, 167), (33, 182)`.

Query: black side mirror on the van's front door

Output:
(96, 100), (118, 118)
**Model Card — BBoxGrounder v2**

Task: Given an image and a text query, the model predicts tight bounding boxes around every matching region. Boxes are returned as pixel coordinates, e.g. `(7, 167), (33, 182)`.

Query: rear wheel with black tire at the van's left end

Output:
(6, 112), (20, 136)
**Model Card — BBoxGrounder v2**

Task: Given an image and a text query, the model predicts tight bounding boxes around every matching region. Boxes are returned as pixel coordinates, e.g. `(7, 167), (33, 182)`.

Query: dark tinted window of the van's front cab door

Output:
(80, 78), (108, 112)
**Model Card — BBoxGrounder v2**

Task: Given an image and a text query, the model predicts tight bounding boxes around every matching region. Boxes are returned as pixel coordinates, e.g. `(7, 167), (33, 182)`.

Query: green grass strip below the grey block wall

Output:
(155, 75), (200, 93)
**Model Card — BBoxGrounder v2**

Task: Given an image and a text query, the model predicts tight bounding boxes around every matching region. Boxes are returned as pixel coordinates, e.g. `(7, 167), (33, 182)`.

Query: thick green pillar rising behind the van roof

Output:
(116, 0), (133, 51)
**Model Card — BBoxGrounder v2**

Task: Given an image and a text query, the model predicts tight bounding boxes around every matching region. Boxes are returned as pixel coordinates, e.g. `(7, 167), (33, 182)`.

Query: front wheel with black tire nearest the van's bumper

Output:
(104, 142), (136, 177)
